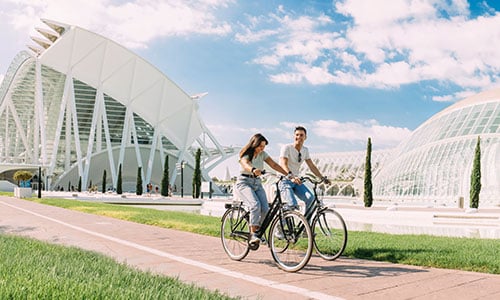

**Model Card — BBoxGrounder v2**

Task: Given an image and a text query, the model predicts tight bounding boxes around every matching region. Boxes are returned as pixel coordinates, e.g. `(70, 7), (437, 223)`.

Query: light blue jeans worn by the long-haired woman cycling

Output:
(235, 175), (269, 226)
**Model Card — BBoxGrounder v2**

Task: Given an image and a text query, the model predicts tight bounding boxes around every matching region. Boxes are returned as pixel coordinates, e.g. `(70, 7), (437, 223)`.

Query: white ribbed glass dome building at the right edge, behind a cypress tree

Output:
(373, 89), (500, 207)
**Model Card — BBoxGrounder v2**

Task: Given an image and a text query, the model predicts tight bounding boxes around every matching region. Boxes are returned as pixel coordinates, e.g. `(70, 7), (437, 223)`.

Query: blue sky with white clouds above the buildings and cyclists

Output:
(0, 0), (500, 178)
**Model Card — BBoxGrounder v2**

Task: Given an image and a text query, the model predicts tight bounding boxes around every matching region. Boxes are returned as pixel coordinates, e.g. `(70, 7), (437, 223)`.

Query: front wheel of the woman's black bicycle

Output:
(269, 211), (313, 272)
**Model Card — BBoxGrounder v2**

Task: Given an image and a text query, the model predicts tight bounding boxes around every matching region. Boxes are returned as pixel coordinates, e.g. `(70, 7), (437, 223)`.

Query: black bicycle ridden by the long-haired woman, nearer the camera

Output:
(221, 175), (313, 272)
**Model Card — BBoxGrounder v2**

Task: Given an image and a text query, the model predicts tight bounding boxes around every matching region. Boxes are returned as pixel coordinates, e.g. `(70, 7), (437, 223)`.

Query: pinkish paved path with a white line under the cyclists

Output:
(0, 197), (500, 299)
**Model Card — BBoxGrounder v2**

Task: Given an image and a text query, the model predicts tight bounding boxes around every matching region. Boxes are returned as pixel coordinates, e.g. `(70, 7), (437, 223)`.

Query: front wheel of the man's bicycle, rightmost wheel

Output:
(312, 209), (347, 260)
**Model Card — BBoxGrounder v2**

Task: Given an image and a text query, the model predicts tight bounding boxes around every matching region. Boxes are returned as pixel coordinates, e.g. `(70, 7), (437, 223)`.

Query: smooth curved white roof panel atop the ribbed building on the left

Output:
(35, 20), (203, 149)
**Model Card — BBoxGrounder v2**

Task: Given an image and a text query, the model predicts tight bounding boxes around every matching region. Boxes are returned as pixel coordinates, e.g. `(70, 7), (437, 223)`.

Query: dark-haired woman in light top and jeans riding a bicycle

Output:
(235, 133), (286, 244)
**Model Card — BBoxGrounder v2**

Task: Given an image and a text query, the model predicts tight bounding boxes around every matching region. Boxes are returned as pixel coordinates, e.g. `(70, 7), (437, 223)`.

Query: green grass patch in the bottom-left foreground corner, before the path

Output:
(0, 234), (231, 299)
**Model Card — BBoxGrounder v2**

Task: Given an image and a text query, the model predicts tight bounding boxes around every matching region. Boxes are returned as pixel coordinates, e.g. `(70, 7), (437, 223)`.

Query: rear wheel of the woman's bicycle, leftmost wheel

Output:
(220, 207), (250, 260)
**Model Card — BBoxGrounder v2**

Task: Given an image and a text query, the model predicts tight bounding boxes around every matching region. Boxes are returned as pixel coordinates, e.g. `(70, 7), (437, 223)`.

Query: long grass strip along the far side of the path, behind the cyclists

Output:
(8, 198), (500, 274)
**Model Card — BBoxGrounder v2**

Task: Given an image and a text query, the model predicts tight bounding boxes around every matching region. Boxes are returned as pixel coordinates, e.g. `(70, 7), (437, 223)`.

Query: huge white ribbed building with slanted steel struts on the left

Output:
(0, 20), (234, 193)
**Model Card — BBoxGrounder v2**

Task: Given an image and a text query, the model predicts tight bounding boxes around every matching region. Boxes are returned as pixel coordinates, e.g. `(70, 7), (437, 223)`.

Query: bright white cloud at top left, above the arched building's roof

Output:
(2, 0), (234, 48)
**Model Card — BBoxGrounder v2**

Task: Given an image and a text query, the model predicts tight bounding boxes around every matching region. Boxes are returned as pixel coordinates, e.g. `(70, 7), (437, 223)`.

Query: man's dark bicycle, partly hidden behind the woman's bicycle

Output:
(300, 176), (347, 261)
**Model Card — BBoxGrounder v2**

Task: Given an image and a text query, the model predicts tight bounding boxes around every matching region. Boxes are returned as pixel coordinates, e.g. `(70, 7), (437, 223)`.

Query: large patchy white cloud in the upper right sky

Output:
(236, 0), (500, 99)
